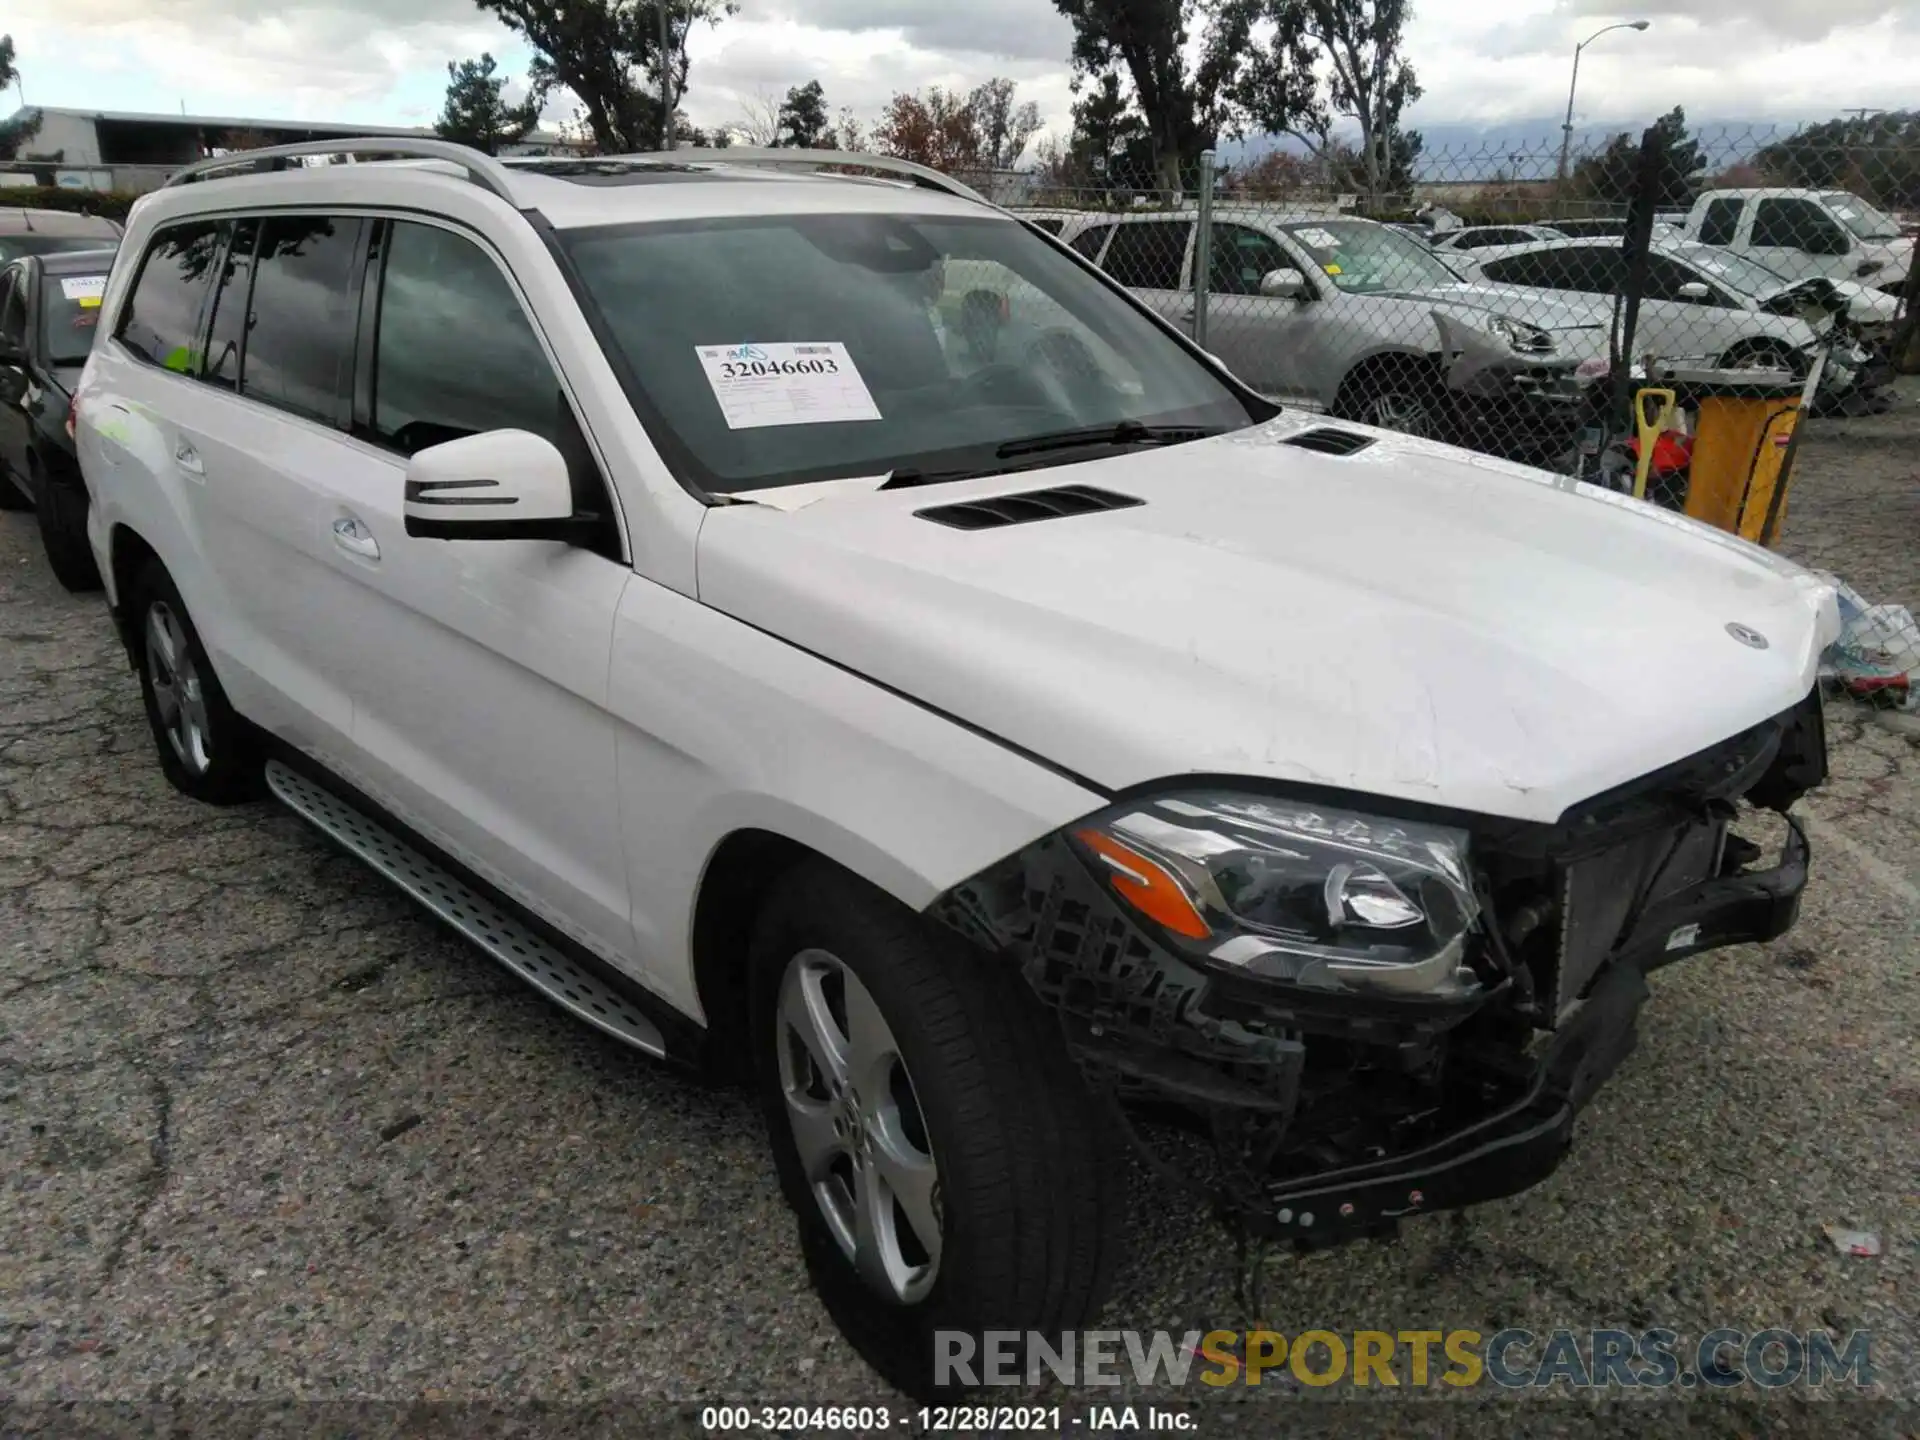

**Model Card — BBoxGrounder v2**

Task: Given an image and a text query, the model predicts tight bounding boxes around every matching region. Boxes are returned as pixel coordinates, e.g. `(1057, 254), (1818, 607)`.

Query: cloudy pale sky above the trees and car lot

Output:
(0, 0), (1920, 155)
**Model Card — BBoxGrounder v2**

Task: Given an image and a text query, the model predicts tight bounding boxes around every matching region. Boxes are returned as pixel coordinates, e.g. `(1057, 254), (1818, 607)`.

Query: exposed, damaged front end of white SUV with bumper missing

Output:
(929, 693), (1826, 1244)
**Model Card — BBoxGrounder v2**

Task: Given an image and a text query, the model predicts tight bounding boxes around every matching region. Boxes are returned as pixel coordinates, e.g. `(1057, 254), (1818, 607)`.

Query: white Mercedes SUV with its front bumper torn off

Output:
(73, 140), (1837, 1394)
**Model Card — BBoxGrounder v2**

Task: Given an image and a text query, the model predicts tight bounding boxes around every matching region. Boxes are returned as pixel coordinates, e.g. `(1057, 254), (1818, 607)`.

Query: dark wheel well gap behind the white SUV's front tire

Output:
(693, 829), (822, 1081)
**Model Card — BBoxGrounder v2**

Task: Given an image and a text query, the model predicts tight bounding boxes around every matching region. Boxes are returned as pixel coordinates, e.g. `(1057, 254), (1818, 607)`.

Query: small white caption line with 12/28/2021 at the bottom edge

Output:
(701, 1404), (1200, 1434)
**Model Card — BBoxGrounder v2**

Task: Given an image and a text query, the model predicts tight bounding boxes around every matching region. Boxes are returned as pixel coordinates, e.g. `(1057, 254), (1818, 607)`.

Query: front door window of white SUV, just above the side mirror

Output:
(372, 221), (572, 455)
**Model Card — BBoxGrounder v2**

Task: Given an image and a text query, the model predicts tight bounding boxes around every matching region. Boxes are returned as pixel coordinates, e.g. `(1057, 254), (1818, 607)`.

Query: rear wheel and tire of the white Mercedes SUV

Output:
(125, 561), (261, 804)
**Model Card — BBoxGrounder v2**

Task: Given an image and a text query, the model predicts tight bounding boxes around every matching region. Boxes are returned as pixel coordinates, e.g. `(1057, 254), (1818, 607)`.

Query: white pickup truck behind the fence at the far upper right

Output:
(1682, 190), (1914, 296)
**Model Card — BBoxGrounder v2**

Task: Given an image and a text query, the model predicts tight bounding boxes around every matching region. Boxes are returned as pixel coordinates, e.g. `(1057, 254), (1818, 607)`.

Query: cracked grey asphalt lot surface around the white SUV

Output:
(0, 382), (1920, 1434)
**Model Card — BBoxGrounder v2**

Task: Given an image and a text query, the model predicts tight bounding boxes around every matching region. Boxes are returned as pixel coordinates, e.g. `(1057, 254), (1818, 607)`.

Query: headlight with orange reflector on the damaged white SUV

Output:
(1068, 791), (1478, 995)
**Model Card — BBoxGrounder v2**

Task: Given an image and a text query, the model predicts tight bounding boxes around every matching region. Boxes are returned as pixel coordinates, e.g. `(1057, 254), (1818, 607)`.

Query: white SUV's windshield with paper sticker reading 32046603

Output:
(563, 215), (1252, 492)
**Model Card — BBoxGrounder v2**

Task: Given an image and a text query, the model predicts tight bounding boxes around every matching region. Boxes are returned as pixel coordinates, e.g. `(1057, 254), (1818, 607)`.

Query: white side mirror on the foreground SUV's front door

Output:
(405, 430), (597, 543)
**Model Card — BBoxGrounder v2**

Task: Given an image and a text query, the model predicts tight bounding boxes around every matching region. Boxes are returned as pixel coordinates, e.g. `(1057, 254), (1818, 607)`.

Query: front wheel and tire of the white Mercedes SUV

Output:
(751, 862), (1121, 1400)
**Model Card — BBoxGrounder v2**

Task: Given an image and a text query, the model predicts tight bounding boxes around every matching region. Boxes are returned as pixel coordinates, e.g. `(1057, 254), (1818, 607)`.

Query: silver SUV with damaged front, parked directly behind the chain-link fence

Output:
(1046, 207), (1611, 459)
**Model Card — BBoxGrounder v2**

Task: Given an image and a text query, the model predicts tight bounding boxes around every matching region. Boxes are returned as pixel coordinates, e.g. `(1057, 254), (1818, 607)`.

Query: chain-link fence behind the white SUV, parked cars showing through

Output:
(993, 115), (1920, 708)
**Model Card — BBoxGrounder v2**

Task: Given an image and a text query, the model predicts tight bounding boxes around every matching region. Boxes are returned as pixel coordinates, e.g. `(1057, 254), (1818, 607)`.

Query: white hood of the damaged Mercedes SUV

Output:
(699, 415), (1839, 820)
